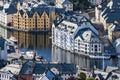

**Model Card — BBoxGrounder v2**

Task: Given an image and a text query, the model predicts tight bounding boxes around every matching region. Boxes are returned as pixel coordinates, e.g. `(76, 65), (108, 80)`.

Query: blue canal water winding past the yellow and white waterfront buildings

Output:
(0, 27), (117, 69)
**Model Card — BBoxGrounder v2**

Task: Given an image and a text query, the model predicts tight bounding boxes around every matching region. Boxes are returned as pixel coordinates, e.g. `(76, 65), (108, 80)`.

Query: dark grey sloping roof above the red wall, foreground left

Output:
(19, 61), (35, 74)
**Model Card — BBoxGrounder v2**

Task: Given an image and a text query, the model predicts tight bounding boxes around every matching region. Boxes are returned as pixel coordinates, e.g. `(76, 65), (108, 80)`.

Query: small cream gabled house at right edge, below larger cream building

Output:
(108, 23), (120, 42)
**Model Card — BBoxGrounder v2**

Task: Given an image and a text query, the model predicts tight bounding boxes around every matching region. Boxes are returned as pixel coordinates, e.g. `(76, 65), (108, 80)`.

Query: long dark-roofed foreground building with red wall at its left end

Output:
(18, 61), (76, 80)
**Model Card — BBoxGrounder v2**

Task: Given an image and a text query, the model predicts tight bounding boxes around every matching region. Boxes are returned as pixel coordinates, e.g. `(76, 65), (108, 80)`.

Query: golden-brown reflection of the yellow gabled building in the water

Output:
(7, 31), (51, 49)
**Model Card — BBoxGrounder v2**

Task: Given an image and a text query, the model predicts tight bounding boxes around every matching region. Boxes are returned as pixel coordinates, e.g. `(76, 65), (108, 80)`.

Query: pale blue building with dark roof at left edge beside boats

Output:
(0, 37), (7, 60)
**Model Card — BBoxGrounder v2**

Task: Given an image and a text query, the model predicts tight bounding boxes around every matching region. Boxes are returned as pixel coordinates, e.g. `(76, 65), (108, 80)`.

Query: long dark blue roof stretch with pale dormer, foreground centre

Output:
(33, 63), (76, 74)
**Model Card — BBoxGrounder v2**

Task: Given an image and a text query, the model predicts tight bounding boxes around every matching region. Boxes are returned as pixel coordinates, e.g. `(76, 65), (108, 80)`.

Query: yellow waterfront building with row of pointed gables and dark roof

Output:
(12, 5), (56, 31)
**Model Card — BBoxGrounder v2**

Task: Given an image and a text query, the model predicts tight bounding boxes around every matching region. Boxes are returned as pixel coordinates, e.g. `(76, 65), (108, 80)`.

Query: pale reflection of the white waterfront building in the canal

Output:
(52, 45), (116, 70)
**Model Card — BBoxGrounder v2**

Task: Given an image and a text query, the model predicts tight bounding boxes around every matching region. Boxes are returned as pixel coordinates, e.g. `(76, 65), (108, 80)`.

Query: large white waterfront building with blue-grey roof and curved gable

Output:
(52, 17), (103, 55)
